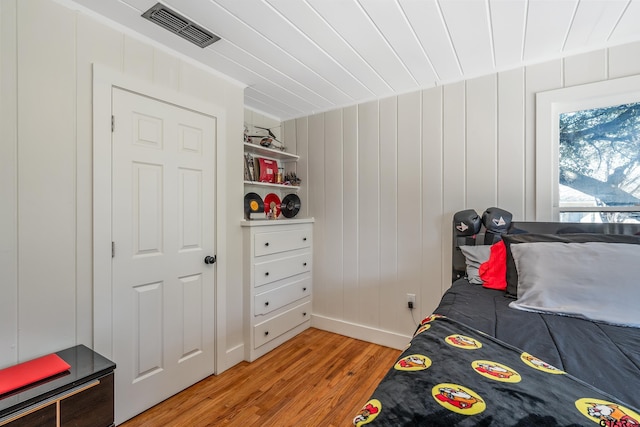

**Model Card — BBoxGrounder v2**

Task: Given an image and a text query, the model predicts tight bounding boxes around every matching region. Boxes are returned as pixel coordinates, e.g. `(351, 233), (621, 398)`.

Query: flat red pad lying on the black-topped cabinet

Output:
(0, 354), (71, 394)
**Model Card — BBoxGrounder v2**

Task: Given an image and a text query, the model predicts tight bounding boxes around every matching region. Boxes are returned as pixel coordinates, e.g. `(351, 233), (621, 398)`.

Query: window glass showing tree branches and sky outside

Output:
(558, 102), (640, 222)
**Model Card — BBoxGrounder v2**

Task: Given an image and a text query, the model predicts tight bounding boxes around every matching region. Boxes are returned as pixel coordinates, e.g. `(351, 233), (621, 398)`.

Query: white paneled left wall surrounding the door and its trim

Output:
(0, 0), (244, 369)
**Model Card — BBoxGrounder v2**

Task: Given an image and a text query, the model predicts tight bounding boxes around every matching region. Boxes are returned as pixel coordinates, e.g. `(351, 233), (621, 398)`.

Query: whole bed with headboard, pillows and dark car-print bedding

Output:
(353, 208), (640, 427)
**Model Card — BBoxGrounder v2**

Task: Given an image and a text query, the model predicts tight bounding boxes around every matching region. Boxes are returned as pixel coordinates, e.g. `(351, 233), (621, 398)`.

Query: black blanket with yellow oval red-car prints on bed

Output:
(353, 315), (640, 427)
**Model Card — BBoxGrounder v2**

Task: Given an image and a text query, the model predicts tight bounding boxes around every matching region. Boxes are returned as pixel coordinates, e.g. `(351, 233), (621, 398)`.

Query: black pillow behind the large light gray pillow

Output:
(502, 233), (640, 298)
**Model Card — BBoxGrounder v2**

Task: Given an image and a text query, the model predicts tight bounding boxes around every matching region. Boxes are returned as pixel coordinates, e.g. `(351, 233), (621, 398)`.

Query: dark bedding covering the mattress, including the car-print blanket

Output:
(354, 280), (640, 427)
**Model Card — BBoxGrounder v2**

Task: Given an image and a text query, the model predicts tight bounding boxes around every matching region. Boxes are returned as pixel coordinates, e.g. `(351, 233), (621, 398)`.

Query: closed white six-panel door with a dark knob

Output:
(112, 88), (216, 424)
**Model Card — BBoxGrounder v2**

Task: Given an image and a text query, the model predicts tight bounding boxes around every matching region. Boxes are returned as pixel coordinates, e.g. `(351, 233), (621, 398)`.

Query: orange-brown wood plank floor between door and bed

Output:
(121, 328), (400, 427)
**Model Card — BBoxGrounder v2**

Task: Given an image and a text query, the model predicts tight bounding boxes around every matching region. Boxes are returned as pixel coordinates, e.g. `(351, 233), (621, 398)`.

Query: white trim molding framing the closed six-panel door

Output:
(93, 64), (229, 373)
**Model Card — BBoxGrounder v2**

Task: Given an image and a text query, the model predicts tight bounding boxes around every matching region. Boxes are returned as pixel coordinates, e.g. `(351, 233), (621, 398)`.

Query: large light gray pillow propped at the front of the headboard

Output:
(509, 242), (640, 327)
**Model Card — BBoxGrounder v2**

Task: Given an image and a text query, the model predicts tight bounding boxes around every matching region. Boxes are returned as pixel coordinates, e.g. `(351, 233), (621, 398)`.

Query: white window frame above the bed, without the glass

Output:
(535, 75), (640, 221)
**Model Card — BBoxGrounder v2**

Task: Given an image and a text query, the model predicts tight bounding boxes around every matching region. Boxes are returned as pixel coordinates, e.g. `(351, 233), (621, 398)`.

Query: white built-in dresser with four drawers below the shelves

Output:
(242, 219), (313, 362)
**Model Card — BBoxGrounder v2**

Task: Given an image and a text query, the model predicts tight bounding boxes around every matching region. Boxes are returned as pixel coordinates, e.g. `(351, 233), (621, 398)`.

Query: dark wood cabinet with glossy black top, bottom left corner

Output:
(0, 345), (116, 427)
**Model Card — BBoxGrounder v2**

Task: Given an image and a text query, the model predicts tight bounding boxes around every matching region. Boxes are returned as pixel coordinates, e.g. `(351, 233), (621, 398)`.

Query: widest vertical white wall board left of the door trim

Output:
(16, 1), (77, 364)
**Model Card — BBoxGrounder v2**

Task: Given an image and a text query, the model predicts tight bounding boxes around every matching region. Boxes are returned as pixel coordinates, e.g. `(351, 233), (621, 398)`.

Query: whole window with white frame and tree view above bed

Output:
(536, 76), (640, 222)
